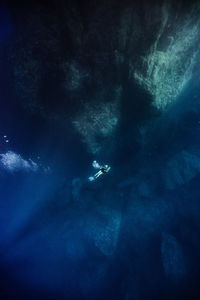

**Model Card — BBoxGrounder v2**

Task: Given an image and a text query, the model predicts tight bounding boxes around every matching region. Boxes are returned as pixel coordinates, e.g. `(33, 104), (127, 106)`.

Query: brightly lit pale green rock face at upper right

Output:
(134, 3), (200, 110)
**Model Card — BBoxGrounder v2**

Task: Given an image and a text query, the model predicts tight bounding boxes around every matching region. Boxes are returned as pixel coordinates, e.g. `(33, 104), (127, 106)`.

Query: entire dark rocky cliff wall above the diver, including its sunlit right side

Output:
(8, 1), (200, 157)
